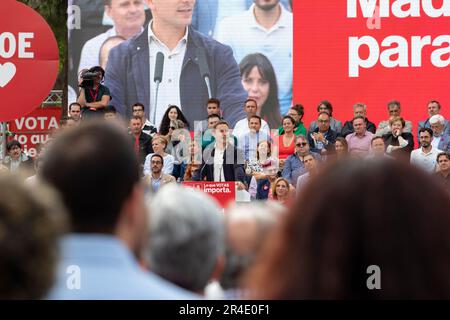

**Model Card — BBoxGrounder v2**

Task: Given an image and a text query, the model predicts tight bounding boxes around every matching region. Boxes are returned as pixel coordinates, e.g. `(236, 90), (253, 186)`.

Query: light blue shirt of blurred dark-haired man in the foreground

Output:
(48, 234), (198, 300)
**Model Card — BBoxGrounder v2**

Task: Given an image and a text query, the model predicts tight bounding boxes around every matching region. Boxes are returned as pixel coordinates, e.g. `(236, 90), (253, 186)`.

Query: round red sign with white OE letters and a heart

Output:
(0, 0), (59, 121)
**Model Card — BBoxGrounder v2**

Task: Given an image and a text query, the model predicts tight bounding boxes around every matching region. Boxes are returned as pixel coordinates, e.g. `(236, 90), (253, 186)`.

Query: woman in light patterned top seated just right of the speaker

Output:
(246, 141), (278, 200)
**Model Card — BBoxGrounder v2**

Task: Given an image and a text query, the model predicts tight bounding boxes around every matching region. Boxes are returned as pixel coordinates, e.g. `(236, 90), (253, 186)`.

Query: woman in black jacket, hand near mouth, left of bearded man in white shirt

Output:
(383, 117), (414, 160)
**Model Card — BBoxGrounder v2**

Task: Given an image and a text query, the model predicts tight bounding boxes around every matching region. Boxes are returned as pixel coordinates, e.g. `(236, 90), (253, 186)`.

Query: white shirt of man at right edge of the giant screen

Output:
(214, 4), (294, 114)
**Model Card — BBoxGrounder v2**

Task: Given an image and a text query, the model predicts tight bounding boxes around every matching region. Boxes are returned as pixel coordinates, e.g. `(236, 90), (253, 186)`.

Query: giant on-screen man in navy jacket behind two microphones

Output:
(105, 0), (247, 128)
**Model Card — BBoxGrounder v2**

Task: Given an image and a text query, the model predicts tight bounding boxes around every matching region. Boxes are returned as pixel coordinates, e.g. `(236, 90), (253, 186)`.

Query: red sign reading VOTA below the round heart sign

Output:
(9, 107), (61, 158)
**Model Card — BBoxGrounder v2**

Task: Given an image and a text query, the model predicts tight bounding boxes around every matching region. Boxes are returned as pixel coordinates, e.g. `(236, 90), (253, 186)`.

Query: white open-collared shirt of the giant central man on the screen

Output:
(148, 22), (188, 127)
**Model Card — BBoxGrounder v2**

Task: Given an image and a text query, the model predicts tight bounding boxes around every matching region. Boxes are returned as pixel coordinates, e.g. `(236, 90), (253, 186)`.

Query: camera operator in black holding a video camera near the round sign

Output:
(77, 66), (111, 119)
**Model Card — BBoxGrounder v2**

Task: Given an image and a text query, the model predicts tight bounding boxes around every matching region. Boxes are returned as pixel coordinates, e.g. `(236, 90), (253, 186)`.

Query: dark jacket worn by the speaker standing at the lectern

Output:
(192, 144), (246, 184)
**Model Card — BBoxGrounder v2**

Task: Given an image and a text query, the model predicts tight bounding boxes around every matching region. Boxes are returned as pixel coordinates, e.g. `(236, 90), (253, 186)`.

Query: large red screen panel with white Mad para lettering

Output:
(293, 0), (450, 133)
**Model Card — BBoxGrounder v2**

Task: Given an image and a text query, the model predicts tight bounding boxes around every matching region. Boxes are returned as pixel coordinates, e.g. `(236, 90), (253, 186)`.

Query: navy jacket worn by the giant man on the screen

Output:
(105, 27), (247, 128)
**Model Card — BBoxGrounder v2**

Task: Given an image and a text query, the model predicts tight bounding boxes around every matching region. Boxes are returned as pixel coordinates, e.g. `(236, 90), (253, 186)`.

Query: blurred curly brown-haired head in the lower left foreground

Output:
(0, 173), (67, 300)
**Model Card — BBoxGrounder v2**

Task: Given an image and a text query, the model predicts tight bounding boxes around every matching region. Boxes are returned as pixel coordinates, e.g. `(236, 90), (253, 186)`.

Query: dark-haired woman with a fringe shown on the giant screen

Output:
(239, 53), (281, 128)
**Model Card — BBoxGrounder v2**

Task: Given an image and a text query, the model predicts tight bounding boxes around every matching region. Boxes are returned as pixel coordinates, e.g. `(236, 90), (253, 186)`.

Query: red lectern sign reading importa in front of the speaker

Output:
(183, 181), (236, 208)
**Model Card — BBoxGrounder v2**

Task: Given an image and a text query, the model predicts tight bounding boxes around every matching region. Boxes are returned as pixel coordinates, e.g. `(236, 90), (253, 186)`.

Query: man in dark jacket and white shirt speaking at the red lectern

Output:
(194, 121), (246, 190)
